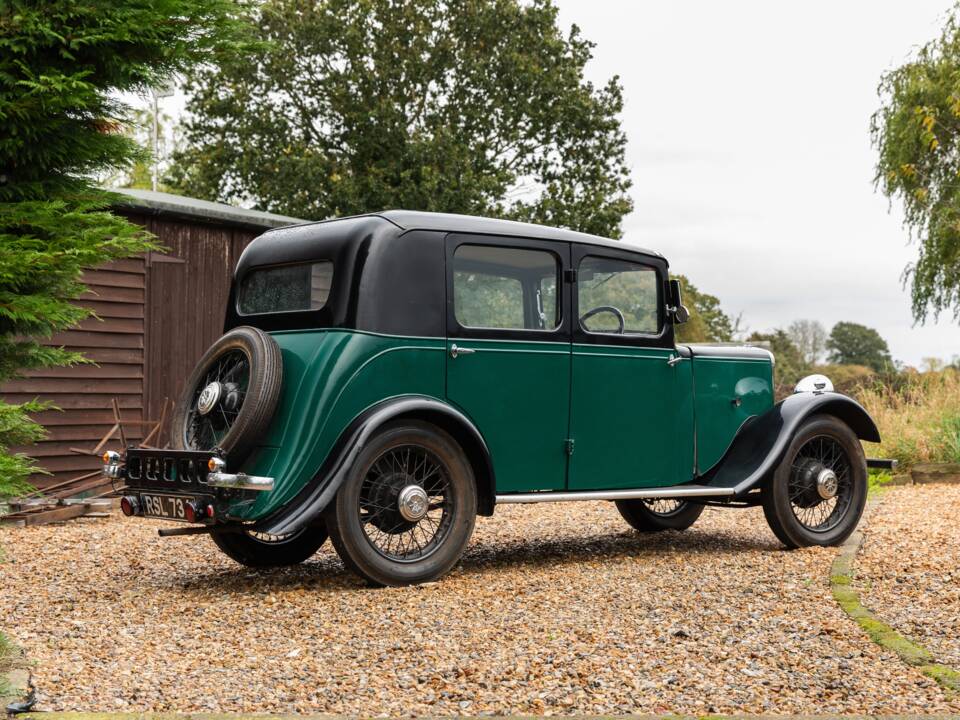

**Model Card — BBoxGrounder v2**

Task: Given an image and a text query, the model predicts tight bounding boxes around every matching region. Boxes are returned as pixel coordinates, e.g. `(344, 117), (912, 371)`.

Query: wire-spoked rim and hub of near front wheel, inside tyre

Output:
(788, 435), (854, 533)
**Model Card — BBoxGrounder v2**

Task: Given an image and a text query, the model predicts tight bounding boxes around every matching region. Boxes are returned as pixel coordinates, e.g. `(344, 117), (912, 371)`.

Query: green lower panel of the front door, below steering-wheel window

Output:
(569, 345), (694, 490)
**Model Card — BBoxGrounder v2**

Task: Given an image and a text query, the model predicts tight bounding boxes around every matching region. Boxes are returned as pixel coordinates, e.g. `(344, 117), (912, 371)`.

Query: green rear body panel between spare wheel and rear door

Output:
(230, 330), (445, 520)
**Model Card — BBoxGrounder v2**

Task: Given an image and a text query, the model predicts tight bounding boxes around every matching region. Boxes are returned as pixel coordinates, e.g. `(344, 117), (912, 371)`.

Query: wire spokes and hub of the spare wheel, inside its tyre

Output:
(183, 350), (250, 450)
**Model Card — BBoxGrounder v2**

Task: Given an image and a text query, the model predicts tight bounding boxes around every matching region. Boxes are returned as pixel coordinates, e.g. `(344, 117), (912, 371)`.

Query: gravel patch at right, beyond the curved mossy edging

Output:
(854, 485), (960, 670)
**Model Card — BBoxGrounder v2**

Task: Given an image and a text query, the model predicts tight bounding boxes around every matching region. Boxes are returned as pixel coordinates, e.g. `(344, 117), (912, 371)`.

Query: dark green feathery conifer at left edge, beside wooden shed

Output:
(0, 0), (246, 496)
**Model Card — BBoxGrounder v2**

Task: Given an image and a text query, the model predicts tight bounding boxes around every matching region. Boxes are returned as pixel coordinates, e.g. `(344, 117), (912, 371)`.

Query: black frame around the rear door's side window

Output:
(446, 233), (571, 343)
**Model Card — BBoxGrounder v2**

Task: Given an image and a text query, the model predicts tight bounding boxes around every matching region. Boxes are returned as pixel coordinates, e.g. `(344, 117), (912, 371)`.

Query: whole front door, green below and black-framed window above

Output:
(569, 245), (694, 490)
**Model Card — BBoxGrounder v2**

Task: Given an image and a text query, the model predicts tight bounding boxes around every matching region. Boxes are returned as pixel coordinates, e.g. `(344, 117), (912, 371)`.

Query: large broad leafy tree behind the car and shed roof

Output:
(172, 0), (632, 237)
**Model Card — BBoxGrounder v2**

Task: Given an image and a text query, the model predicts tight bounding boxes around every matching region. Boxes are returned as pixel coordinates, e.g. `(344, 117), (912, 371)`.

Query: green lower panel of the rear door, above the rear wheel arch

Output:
(447, 340), (570, 493)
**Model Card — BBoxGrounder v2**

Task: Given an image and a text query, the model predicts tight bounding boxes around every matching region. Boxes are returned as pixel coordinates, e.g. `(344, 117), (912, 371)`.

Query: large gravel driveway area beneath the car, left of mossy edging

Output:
(0, 503), (960, 716)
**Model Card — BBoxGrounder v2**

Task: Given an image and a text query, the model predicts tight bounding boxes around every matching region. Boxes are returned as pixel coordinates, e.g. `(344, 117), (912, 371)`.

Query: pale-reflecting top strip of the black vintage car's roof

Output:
(267, 210), (663, 258)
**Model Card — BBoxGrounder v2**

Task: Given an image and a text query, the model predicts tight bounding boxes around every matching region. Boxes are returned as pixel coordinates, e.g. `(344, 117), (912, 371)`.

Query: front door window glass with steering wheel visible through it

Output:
(577, 255), (660, 335)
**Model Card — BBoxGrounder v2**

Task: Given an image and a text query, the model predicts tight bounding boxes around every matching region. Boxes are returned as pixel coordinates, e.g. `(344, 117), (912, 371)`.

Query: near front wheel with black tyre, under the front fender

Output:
(761, 415), (867, 548)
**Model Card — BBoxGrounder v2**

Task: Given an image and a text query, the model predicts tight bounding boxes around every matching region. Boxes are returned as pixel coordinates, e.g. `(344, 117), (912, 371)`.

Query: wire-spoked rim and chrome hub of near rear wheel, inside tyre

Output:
(357, 445), (455, 562)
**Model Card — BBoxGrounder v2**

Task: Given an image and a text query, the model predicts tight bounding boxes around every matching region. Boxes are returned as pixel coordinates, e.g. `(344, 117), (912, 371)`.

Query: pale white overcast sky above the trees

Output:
(152, 0), (960, 366)
